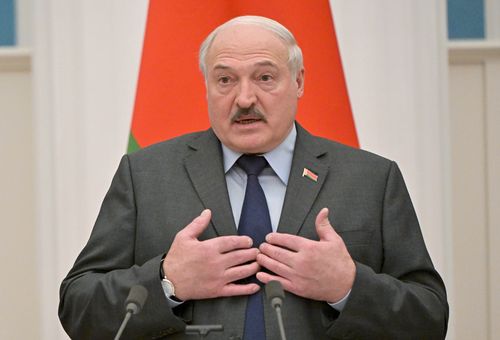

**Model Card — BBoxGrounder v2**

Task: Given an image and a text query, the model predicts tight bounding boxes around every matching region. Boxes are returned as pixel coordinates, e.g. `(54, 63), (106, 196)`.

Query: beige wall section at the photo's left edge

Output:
(0, 49), (40, 339)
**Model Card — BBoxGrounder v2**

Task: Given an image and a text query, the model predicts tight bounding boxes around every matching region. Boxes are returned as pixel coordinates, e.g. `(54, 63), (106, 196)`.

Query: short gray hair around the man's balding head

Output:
(199, 15), (304, 80)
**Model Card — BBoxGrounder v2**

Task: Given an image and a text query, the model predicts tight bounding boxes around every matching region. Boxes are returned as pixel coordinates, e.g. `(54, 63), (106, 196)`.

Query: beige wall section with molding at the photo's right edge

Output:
(449, 42), (500, 340)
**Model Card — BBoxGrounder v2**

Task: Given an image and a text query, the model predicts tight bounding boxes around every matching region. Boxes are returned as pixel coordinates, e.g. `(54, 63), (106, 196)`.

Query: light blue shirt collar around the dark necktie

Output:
(221, 123), (297, 185)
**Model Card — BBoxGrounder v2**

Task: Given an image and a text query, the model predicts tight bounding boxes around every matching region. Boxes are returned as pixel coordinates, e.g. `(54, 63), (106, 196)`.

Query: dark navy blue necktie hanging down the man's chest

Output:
(237, 155), (272, 340)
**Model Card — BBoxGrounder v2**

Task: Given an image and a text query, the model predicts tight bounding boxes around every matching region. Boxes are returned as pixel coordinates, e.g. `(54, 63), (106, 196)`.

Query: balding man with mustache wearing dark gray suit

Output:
(59, 17), (448, 340)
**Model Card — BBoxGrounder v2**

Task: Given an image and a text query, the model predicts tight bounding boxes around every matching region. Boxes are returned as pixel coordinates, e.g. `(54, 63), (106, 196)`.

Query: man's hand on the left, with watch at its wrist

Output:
(163, 209), (260, 301)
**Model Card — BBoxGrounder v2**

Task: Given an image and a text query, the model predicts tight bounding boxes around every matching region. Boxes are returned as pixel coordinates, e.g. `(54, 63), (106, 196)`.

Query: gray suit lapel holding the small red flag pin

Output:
(278, 124), (328, 234)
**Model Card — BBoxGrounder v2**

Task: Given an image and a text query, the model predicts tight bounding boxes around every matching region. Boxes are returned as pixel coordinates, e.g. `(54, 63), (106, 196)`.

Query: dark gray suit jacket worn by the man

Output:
(59, 125), (448, 340)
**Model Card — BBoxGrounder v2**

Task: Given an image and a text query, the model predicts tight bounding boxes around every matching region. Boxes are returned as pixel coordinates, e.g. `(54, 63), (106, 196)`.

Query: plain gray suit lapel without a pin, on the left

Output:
(184, 129), (236, 236)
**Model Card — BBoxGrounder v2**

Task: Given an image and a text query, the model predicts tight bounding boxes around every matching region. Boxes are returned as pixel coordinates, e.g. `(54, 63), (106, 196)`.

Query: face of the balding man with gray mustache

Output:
(206, 25), (304, 153)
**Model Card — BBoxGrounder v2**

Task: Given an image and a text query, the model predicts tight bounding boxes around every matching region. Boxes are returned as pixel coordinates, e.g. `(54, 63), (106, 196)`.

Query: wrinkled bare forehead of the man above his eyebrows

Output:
(206, 24), (288, 68)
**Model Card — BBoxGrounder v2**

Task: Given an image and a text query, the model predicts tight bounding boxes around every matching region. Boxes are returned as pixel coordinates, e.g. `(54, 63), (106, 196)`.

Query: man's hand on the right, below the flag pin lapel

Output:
(257, 208), (356, 303)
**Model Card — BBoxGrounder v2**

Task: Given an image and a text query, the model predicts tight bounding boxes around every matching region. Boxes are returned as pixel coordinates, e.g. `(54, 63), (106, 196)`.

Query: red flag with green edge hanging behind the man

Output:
(128, 0), (358, 152)
